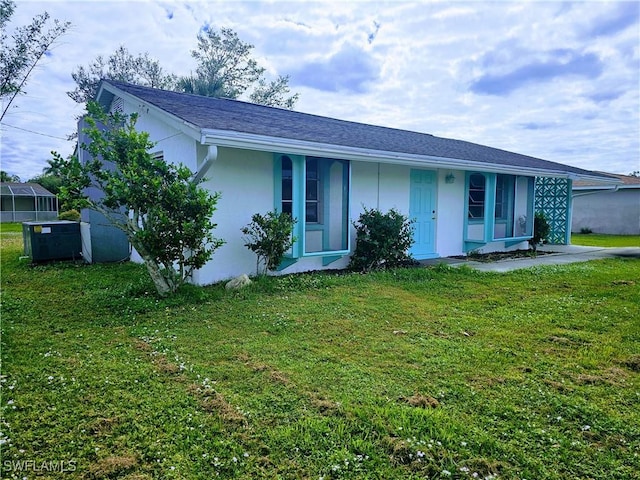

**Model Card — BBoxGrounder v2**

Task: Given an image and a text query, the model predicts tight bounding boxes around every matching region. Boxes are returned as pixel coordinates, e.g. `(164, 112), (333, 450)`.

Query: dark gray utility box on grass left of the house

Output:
(22, 220), (82, 262)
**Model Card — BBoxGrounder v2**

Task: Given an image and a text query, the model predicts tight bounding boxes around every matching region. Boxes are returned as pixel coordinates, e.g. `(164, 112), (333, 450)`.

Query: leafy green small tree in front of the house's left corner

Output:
(54, 102), (223, 296)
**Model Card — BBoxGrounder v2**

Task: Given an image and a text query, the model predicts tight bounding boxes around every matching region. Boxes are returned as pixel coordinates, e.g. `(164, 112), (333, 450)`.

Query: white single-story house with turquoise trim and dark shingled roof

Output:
(80, 80), (606, 284)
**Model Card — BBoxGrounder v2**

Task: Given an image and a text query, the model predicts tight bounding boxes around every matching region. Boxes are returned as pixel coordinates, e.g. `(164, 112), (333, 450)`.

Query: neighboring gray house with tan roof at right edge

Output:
(571, 172), (640, 235)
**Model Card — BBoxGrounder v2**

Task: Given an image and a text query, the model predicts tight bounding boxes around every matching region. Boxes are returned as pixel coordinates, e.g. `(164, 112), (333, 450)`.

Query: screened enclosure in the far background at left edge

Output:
(0, 182), (58, 223)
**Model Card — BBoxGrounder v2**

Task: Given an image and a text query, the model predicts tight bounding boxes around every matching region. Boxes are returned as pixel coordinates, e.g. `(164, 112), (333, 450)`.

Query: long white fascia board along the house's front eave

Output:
(202, 129), (596, 178)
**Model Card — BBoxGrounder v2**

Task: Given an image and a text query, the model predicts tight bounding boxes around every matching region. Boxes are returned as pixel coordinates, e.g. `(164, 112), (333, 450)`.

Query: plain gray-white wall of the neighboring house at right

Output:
(571, 188), (640, 235)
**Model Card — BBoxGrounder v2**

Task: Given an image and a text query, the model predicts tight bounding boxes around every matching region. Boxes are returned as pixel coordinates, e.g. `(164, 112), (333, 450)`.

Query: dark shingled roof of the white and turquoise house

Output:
(103, 80), (600, 177)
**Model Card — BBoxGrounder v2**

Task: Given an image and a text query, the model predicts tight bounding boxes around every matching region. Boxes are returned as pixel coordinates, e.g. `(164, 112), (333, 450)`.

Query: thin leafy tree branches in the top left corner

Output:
(0, 0), (71, 120)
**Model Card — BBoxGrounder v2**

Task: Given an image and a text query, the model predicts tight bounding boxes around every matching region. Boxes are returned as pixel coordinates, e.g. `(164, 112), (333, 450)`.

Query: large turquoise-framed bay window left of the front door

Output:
(275, 155), (350, 258)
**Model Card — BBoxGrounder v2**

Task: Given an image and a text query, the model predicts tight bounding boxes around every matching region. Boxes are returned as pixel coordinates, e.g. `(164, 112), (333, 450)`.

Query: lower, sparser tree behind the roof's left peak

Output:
(67, 45), (177, 103)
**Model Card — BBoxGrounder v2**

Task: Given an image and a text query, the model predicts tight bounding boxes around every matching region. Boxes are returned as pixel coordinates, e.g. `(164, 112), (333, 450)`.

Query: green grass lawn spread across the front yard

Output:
(0, 226), (640, 480)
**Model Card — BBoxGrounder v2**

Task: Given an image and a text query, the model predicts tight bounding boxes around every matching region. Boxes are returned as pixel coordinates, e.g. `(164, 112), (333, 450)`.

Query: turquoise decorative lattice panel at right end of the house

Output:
(535, 177), (571, 245)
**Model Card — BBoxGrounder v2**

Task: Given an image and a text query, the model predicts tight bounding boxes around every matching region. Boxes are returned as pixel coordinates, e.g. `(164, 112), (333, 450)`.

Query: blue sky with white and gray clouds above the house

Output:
(0, 0), (640, 180)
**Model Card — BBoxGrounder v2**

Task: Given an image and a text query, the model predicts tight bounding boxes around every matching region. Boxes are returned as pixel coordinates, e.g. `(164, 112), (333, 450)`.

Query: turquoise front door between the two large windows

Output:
(409, 169), (438, 260)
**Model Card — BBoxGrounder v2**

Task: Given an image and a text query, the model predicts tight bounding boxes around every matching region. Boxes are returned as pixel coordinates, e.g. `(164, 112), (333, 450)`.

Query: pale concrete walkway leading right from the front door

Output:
(421, 245), (640, 272)
